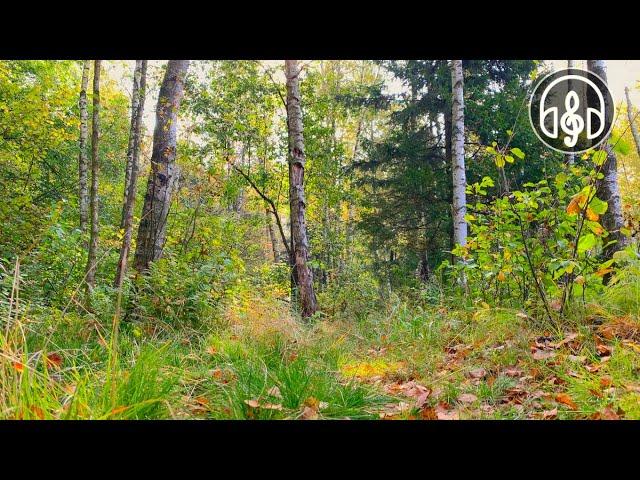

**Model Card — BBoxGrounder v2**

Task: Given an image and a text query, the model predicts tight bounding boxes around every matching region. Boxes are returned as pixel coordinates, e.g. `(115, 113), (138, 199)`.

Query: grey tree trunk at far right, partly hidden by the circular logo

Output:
(587, 60), (629, 257)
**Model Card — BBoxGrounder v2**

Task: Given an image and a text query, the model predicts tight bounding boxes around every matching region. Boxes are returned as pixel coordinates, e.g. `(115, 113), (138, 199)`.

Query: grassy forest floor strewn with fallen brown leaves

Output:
(0, 274), (640, 420)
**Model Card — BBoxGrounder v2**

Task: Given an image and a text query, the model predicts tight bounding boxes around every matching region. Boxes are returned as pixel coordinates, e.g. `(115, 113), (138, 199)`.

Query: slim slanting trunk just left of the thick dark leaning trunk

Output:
(114, 60), (147, 288)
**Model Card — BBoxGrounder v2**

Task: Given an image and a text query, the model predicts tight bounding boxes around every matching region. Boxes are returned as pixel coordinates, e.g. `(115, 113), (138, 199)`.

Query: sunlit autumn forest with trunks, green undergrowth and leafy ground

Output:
(0, 59), (640, 420)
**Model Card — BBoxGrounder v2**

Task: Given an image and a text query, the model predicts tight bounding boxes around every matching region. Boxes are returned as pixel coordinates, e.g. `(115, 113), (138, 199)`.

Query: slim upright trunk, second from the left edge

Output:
(86, 60), (101, 291)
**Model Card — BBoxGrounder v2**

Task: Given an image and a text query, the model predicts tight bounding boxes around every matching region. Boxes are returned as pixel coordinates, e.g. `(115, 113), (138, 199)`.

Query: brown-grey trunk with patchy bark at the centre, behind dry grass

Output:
(285, 60), (318, 317)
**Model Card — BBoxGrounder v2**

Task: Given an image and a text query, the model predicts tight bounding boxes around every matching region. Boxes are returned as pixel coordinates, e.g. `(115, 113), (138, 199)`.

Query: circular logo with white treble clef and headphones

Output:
(529, 68), (615, 153)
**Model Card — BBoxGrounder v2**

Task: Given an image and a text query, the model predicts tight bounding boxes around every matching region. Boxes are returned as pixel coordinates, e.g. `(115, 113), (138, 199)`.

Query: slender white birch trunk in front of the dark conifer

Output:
(451, 60), (467, 246)
